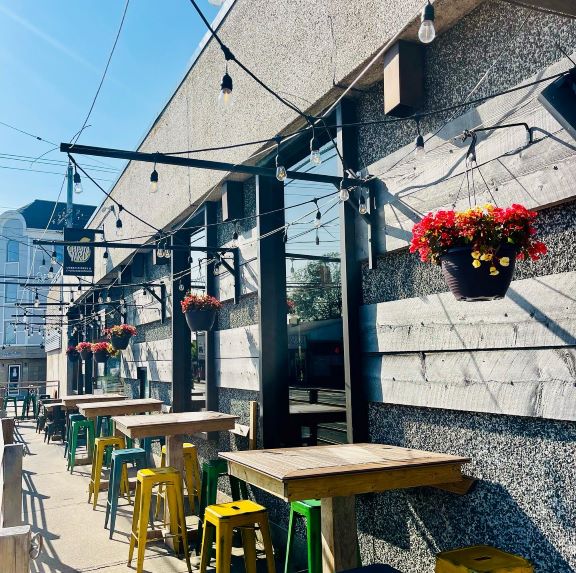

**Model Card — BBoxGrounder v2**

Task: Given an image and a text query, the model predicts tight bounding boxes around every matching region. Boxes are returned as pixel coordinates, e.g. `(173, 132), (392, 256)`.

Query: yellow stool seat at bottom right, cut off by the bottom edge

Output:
(435, 545), (534, 573)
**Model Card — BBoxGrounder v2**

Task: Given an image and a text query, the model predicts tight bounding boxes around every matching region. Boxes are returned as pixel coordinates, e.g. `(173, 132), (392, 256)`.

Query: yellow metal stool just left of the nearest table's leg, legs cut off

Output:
(200, 500), (276, 573)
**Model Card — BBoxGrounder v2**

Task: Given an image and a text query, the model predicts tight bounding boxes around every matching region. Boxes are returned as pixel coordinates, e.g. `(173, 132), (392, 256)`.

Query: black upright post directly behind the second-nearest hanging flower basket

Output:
(171, 231), (192, 412)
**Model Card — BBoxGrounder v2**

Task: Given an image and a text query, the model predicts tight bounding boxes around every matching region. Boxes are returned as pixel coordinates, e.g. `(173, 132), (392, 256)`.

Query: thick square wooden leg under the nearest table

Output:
(321, 495), (358, 573)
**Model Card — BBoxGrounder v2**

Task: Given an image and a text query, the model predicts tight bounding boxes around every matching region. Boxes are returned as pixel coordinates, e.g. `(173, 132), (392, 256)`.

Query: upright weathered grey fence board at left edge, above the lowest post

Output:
(0, 444), (24, 527)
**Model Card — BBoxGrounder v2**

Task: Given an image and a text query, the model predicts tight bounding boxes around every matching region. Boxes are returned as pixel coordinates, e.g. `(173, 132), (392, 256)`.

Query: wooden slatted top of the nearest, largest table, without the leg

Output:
(219, 444), (470, 501)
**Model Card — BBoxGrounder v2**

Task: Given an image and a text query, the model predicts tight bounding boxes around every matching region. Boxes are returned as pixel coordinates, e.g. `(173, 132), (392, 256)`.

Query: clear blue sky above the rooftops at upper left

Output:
(0, 0), (218, 212)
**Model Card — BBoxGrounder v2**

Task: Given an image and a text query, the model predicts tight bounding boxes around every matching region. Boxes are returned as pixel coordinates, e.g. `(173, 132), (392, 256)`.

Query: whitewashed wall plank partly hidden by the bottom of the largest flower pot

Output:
(360, 272), (576, 353)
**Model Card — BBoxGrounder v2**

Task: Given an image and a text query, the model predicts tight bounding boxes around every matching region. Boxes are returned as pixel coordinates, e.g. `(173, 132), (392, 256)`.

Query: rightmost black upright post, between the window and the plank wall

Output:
(337, 100), (368, 443)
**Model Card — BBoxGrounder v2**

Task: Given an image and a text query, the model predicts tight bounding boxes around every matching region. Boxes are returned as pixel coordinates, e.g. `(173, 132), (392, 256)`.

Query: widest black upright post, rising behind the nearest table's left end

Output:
(256, 176), (289, 448)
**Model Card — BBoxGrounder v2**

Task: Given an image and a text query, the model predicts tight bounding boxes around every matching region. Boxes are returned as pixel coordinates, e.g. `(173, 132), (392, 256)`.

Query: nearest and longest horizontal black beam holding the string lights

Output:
(60, 143), (358, 187)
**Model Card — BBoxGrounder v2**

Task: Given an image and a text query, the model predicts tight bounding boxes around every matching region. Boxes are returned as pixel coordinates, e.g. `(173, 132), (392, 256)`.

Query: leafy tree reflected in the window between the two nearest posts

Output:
(289, 254), (342, 322)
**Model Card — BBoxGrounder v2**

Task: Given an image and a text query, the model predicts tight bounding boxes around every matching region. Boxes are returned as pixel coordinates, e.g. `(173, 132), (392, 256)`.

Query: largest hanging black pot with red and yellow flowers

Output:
(410, 204), (546, 301)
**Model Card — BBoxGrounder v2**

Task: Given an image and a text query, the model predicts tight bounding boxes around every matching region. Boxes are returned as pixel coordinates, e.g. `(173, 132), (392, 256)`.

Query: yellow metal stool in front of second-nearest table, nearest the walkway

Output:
(128, 466), (192, 573)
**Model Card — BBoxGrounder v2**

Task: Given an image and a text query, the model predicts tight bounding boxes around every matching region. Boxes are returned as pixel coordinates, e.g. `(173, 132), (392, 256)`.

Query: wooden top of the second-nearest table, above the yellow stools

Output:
(112, 411), (238, 438)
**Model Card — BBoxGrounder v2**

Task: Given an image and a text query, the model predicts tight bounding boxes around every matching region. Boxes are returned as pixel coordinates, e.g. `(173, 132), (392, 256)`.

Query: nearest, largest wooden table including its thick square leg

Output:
(219, 444), (470, 573)
